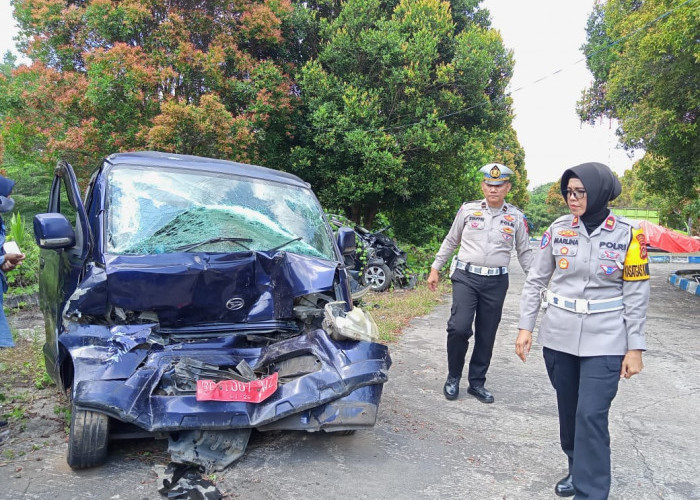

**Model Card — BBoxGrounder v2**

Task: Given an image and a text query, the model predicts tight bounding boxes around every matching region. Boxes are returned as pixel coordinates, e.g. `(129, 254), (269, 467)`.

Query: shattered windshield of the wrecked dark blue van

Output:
(106, 166), (335, 260)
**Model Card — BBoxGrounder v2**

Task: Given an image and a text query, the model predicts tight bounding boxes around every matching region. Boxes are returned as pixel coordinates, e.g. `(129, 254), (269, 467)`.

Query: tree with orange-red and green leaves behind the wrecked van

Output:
(0, 0), (297, 178)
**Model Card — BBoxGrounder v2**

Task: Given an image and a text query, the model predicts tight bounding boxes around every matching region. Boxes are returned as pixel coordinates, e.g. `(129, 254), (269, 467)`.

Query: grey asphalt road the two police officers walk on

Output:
(0, 263), (700, 500)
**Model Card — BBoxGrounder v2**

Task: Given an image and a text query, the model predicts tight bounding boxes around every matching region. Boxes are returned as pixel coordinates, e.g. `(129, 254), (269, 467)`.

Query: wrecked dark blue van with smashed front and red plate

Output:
(34, 152), (391, 470)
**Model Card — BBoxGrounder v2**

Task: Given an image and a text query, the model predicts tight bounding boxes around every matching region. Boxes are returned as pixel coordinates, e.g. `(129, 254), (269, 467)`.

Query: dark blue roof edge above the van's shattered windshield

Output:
(105, 151), (310, 188)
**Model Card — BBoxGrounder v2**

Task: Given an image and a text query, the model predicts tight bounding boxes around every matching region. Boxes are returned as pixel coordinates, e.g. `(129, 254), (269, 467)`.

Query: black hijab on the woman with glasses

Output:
(561, 162), (622, 234)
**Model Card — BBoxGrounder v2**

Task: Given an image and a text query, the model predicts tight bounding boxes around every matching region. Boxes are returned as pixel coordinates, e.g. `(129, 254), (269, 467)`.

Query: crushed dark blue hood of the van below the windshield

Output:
(64, 252), (338, 328)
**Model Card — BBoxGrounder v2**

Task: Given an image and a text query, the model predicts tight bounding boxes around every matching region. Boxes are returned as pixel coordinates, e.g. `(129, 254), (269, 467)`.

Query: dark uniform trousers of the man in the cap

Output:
(447, 269), (508, 387)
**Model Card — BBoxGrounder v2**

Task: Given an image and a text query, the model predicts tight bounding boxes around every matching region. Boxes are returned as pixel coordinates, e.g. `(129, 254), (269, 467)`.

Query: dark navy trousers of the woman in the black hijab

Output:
(543, 347), (624, 500)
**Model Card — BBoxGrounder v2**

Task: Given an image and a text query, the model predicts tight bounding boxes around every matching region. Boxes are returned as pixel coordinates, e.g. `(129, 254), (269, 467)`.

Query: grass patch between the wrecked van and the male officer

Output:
(360, 279), (452, 343)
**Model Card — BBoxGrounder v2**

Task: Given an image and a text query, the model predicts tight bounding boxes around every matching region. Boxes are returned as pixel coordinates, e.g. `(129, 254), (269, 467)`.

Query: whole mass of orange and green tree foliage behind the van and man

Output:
(0, 0), (528, 245)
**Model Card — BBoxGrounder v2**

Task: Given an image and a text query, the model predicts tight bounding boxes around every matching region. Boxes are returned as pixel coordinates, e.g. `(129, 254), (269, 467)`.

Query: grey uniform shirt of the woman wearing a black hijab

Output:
(518, 214), (649, 356)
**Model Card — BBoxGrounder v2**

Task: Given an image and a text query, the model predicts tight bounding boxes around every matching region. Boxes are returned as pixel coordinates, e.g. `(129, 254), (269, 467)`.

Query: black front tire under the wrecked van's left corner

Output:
(67, 406), (109, 469)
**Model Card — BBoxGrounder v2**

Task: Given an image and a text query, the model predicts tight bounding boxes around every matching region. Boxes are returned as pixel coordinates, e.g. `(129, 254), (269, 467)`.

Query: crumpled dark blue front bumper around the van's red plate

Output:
(65, 325), (391, 432)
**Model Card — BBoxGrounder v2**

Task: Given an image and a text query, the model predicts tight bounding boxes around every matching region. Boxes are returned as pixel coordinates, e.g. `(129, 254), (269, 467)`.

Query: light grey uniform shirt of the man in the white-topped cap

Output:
(431, 200), (533, 273)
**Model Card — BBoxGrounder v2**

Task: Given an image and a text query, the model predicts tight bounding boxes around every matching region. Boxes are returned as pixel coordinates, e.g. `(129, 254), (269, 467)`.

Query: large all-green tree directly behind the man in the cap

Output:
(291, 0), (527, 245)
